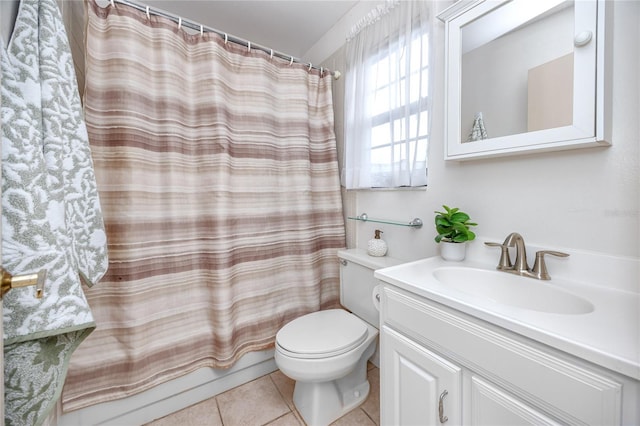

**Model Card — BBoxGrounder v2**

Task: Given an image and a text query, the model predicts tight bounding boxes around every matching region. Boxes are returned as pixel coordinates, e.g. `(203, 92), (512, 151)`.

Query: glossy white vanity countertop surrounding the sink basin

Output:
(375, 257), (640, 380)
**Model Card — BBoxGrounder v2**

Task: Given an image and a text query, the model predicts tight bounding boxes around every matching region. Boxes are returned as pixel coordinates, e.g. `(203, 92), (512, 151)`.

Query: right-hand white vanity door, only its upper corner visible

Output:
(468, 375), (560, 426)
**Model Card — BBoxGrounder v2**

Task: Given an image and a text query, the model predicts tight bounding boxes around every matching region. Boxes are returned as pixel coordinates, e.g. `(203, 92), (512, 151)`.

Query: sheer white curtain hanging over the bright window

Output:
(342, 1), (431, 189)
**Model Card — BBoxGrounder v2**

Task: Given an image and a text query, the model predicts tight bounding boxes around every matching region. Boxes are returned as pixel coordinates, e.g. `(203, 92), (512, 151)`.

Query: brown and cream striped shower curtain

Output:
(63, 0), (345, 411)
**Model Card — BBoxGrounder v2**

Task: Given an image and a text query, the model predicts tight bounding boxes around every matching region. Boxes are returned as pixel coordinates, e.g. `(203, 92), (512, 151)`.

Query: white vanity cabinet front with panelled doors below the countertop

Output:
(380, 283), (624, 425)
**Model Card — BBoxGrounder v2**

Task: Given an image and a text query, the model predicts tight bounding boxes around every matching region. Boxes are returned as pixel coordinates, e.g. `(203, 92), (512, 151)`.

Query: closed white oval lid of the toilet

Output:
(276, 309), (367, 358)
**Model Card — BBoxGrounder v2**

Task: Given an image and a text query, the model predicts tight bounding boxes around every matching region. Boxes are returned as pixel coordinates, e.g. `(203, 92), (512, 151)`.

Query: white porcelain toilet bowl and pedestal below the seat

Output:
(293, 341), (376, 426)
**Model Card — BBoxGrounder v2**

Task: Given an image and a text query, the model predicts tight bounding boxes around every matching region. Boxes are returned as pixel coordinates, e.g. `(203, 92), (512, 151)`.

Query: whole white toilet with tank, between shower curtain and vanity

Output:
(275, 249), (400, 426)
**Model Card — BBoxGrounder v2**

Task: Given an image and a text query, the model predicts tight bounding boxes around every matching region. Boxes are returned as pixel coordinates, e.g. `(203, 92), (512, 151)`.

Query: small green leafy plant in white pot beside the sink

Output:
(434, 205), (477, 260)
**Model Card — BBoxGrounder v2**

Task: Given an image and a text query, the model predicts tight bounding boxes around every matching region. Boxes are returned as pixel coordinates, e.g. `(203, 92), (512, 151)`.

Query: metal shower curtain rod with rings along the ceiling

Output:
(107, 0), (341, 80)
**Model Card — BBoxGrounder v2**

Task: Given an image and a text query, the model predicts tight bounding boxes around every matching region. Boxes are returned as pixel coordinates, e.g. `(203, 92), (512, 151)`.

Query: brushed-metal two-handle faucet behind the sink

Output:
(485, 232), (569, 280)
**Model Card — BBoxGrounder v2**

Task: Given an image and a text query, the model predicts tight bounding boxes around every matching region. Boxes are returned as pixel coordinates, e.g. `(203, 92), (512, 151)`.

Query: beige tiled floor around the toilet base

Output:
(148, 363), (380, 426)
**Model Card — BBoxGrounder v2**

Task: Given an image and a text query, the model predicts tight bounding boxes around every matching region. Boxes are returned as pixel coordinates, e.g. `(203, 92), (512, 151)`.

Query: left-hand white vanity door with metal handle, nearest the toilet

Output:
(380, 326), (462, 425)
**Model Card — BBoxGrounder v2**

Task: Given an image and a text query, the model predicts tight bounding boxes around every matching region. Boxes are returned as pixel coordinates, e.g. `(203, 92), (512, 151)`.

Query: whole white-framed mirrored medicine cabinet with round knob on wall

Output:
(439, 0), (610, 160)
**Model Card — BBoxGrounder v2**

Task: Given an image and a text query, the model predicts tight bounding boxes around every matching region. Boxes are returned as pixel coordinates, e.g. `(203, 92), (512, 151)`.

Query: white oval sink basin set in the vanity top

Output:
(432, 266), (594, 315)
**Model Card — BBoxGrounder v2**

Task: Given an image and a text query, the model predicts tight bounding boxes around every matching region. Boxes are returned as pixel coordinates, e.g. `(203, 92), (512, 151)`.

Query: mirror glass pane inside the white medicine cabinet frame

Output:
(460, 1), (574, 142)
